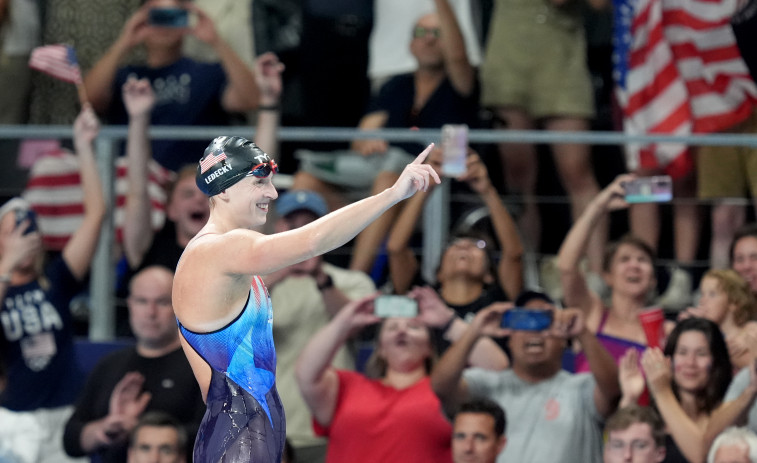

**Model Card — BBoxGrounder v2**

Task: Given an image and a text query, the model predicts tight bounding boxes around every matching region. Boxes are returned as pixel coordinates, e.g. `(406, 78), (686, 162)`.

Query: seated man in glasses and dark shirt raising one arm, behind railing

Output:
(293, 0), (478, 280)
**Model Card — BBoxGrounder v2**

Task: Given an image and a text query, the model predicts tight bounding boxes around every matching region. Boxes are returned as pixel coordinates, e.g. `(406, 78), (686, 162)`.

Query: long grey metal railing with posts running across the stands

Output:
(0, 125), (757, 341)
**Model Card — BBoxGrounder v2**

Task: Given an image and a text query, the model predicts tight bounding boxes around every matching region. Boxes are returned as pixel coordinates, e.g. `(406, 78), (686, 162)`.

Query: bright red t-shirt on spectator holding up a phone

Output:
(313, 371), (452, 463)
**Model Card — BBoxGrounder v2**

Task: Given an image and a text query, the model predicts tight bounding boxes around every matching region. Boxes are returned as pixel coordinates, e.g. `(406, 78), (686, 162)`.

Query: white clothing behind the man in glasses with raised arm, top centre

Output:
(368, 0), (481, 79)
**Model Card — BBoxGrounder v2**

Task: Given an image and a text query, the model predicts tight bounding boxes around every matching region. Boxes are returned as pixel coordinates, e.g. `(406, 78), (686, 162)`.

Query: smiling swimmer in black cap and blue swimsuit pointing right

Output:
(173, 137), (440, 463)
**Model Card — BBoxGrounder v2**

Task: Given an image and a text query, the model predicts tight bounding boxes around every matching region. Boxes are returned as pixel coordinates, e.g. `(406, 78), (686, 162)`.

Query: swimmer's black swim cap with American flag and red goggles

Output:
(195, 137), (278, 196)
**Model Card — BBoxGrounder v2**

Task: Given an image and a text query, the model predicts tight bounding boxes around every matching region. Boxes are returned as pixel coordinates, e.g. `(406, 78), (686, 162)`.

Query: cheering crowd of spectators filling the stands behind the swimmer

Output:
(0, 0), (757, 463)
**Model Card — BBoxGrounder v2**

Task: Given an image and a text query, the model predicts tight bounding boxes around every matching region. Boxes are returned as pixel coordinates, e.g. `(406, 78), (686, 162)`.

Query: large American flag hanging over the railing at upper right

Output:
(613, 0), (757, 176)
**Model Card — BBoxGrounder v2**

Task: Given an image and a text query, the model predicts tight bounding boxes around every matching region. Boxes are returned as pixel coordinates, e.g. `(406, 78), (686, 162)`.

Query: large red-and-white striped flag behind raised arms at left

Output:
(22, 150), (174, 250)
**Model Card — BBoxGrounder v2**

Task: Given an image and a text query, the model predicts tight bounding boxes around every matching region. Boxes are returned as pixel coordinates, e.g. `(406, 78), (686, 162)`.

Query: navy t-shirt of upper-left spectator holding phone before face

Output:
(108, 58), (228, 170)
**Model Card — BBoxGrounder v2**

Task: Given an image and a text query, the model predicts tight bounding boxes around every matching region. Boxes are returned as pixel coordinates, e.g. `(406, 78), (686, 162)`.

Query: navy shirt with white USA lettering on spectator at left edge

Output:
(0, 257), (82, 411)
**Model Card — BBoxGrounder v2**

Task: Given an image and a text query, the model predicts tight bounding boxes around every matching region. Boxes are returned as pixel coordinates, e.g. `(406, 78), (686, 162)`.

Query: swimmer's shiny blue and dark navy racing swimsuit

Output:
(179, 276), (286, 463)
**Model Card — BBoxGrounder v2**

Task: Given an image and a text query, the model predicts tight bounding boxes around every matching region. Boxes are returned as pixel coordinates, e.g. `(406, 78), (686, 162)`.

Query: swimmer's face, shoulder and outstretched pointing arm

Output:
(187, 141), (440, 275)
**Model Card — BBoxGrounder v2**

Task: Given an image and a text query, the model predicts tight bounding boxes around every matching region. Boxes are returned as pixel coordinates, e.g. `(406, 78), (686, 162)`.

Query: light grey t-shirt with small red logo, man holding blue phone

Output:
(463, 368), (603, 463)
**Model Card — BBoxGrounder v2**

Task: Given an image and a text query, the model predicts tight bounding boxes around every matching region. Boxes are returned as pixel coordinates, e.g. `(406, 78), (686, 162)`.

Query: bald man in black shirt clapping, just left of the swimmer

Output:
(63, 266), (205, 463)
